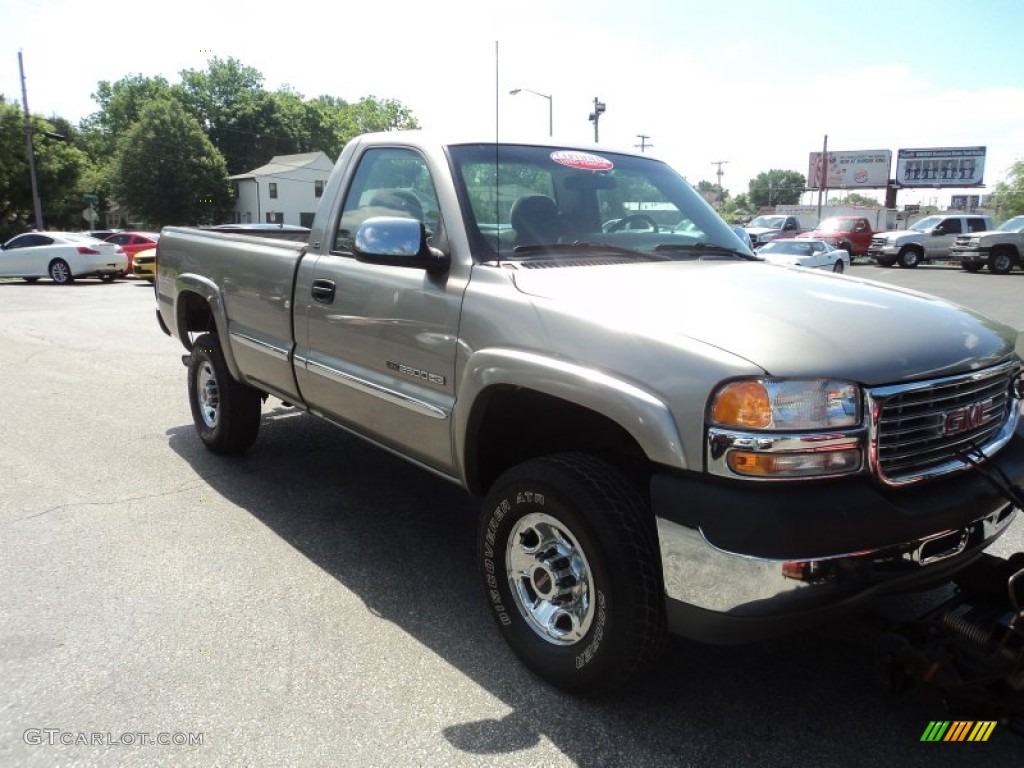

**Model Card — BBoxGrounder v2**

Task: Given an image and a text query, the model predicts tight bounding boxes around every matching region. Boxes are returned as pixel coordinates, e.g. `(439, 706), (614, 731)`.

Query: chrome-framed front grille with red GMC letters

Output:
(867, 362), (1020, 485)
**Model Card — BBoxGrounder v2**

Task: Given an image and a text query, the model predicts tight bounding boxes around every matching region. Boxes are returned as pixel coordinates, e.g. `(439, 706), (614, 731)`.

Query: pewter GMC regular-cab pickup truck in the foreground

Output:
(156, 132), (1024, 692)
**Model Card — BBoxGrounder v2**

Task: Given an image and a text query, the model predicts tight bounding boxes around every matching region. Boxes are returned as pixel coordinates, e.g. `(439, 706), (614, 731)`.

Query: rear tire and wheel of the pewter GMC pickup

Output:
(188, 334), (261, 455)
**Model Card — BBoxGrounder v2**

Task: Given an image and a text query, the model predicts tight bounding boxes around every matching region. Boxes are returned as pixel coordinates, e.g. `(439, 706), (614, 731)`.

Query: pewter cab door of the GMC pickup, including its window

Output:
(295, 147), (464, 472)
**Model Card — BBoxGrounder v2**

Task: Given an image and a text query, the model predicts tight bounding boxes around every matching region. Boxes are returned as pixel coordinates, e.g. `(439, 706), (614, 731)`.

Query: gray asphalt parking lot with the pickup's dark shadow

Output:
(0, 263), (1024, 768)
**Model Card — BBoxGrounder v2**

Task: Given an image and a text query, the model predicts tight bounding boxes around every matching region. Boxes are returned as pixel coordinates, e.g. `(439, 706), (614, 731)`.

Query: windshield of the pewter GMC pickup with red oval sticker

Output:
(450, 144), (751, 260)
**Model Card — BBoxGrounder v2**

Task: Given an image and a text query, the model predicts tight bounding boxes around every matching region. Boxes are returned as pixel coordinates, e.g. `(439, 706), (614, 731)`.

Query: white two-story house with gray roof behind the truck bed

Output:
(230, 152), (334, 226)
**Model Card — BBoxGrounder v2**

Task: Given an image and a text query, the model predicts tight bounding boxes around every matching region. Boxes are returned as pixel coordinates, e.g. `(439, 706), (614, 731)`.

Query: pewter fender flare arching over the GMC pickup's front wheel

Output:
(453, 349), (686, 479)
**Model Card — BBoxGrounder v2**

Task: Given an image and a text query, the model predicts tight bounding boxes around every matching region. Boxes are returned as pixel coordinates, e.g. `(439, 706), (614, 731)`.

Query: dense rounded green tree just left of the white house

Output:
(113, 98), (232, 228)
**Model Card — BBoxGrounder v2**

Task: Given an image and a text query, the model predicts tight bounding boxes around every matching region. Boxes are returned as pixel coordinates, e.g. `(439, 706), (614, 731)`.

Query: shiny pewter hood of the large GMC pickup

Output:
(514, 261), (1017, 386)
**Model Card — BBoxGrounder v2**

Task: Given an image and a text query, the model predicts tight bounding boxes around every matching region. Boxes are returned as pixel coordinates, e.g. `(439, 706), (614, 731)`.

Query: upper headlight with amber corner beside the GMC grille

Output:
(711, 379), (860, 431)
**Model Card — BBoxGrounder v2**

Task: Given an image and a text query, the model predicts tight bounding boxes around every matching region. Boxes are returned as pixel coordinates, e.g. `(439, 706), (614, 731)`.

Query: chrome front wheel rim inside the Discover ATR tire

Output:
(505, 513), (596, 645)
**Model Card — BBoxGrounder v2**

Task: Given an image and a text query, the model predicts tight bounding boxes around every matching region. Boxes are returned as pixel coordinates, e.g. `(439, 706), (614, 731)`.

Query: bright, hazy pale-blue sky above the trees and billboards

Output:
(0, 0), (1024, 206)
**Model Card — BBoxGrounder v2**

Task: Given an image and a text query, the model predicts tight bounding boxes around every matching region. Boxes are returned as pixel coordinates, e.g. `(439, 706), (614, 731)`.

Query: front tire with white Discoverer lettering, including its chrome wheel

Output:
(479, 454), (667, 694)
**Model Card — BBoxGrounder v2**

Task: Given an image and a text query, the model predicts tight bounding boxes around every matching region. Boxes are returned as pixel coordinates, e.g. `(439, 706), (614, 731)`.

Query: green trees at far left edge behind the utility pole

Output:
(0, 97), (89, 241)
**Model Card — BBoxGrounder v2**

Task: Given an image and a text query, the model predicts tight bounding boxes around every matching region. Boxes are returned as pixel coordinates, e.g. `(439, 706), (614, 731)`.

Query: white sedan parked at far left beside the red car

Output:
(0, 232), (128, 285)
